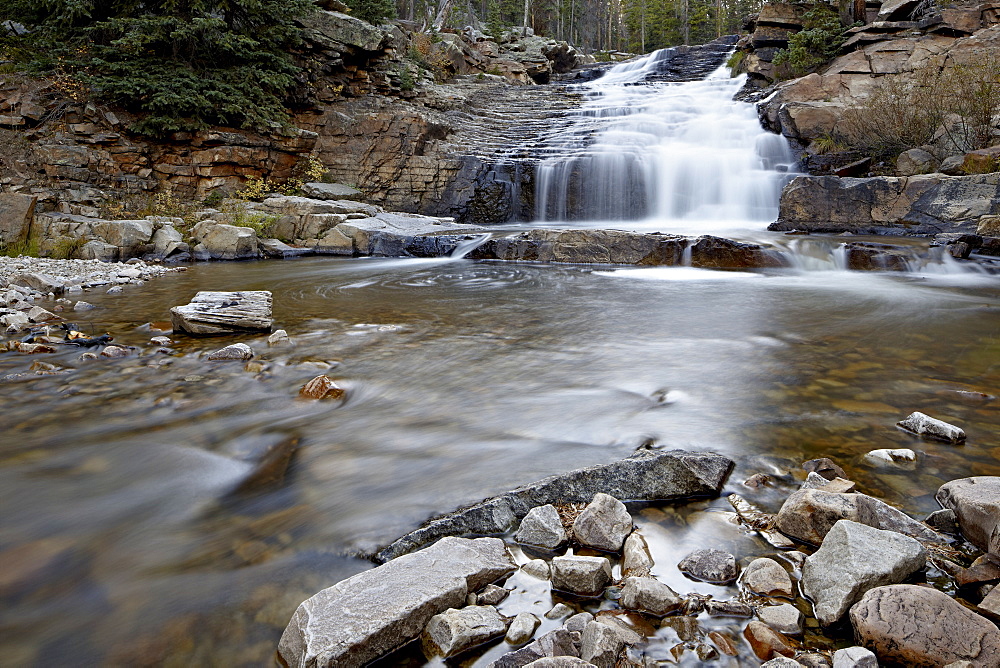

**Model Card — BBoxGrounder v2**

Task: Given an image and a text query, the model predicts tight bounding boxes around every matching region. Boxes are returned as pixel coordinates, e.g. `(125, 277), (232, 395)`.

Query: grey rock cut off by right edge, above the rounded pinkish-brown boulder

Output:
(934, 476), (1000, 557)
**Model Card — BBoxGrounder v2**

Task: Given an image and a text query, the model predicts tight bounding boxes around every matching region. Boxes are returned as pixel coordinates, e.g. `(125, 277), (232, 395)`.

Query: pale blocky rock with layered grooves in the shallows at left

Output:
(170, 290), (273, 334)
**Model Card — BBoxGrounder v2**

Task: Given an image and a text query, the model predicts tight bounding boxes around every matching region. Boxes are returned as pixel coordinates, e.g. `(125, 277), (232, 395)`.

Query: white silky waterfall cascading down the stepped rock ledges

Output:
(535, 49), (795, 233)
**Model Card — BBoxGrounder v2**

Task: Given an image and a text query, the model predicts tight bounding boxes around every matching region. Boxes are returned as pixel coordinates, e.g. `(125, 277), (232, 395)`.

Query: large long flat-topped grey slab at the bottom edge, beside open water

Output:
(278, 537), (515, 666)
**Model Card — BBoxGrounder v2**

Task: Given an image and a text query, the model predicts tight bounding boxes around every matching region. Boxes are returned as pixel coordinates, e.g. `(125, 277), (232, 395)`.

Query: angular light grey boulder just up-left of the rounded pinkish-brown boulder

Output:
(802, 520), (927, 626)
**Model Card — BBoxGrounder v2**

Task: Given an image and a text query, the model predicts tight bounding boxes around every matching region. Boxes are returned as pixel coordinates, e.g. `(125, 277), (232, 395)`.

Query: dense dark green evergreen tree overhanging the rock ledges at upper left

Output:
(0, 0), (315, 135)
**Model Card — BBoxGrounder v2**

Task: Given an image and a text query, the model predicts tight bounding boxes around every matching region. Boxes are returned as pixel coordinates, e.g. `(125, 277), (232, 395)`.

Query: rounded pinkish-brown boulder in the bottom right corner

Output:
(850, 585), (1000, 668)
